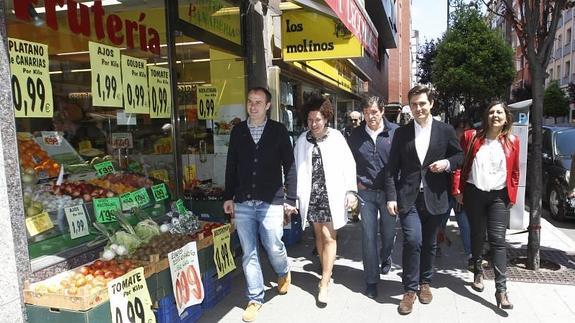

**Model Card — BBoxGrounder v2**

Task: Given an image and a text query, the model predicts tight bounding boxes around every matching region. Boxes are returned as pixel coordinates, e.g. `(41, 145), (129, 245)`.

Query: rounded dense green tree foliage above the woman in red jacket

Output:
(432, 4), (515, 115)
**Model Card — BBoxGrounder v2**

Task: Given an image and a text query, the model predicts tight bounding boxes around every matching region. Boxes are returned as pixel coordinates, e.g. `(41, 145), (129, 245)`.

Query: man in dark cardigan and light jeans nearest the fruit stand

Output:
(224, 87), (297, 322)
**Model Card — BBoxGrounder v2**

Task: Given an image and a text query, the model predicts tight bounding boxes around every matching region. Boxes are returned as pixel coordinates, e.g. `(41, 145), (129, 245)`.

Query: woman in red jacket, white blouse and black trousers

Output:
(453, 102), (519, 309)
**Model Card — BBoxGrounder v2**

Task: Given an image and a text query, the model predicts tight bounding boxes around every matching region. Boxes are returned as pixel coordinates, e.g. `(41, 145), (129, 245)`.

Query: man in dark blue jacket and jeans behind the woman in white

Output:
(348, 97), (398, 298)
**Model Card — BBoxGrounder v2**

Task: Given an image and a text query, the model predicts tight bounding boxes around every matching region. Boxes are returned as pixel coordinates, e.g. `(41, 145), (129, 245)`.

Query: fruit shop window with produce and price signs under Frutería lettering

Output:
(6, 1), (177, 259)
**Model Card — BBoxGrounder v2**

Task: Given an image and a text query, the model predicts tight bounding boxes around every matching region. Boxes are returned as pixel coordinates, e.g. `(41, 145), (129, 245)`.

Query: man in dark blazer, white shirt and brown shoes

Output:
(385, 85), (463, 314)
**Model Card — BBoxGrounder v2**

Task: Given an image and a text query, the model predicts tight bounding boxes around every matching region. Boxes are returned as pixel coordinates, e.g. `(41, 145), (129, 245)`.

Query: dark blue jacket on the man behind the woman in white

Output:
(348, 118), (399, 190)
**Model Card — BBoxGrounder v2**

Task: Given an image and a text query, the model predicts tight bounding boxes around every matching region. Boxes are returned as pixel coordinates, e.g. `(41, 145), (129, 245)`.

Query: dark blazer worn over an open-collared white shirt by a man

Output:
(385, 120), (463, 214)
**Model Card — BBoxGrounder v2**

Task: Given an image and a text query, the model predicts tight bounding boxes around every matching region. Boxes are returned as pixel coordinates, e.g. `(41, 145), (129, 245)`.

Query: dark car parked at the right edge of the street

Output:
(541, 125), (575, 221)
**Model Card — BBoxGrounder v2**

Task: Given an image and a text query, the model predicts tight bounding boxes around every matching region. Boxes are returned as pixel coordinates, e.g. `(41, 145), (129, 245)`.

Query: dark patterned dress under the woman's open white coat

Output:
(306, 131), (331, 223)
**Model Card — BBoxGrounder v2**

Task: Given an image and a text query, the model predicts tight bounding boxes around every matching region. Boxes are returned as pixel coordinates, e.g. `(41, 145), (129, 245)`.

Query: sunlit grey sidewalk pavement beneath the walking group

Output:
(200, 213), (575, 323)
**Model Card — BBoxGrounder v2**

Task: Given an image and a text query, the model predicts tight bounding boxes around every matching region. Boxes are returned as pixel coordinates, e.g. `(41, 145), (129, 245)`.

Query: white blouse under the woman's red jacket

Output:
(467, 139), (507, 192)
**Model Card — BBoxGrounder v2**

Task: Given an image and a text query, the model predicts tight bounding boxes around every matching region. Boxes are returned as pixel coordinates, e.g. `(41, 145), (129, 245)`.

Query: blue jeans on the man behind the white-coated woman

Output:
(359, 190), (397, 284)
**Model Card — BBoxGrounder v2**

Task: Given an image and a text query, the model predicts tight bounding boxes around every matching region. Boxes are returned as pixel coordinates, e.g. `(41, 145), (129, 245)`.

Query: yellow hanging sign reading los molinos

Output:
(282, 10), (363, 61)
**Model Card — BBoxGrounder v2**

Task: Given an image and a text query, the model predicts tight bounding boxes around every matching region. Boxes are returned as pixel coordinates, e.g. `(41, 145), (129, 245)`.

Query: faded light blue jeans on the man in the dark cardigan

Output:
(235, 201), (289, 304)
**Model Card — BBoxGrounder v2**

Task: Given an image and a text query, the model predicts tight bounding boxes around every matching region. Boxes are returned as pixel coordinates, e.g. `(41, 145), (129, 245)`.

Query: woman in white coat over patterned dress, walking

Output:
(295, 97), (357, 304)
